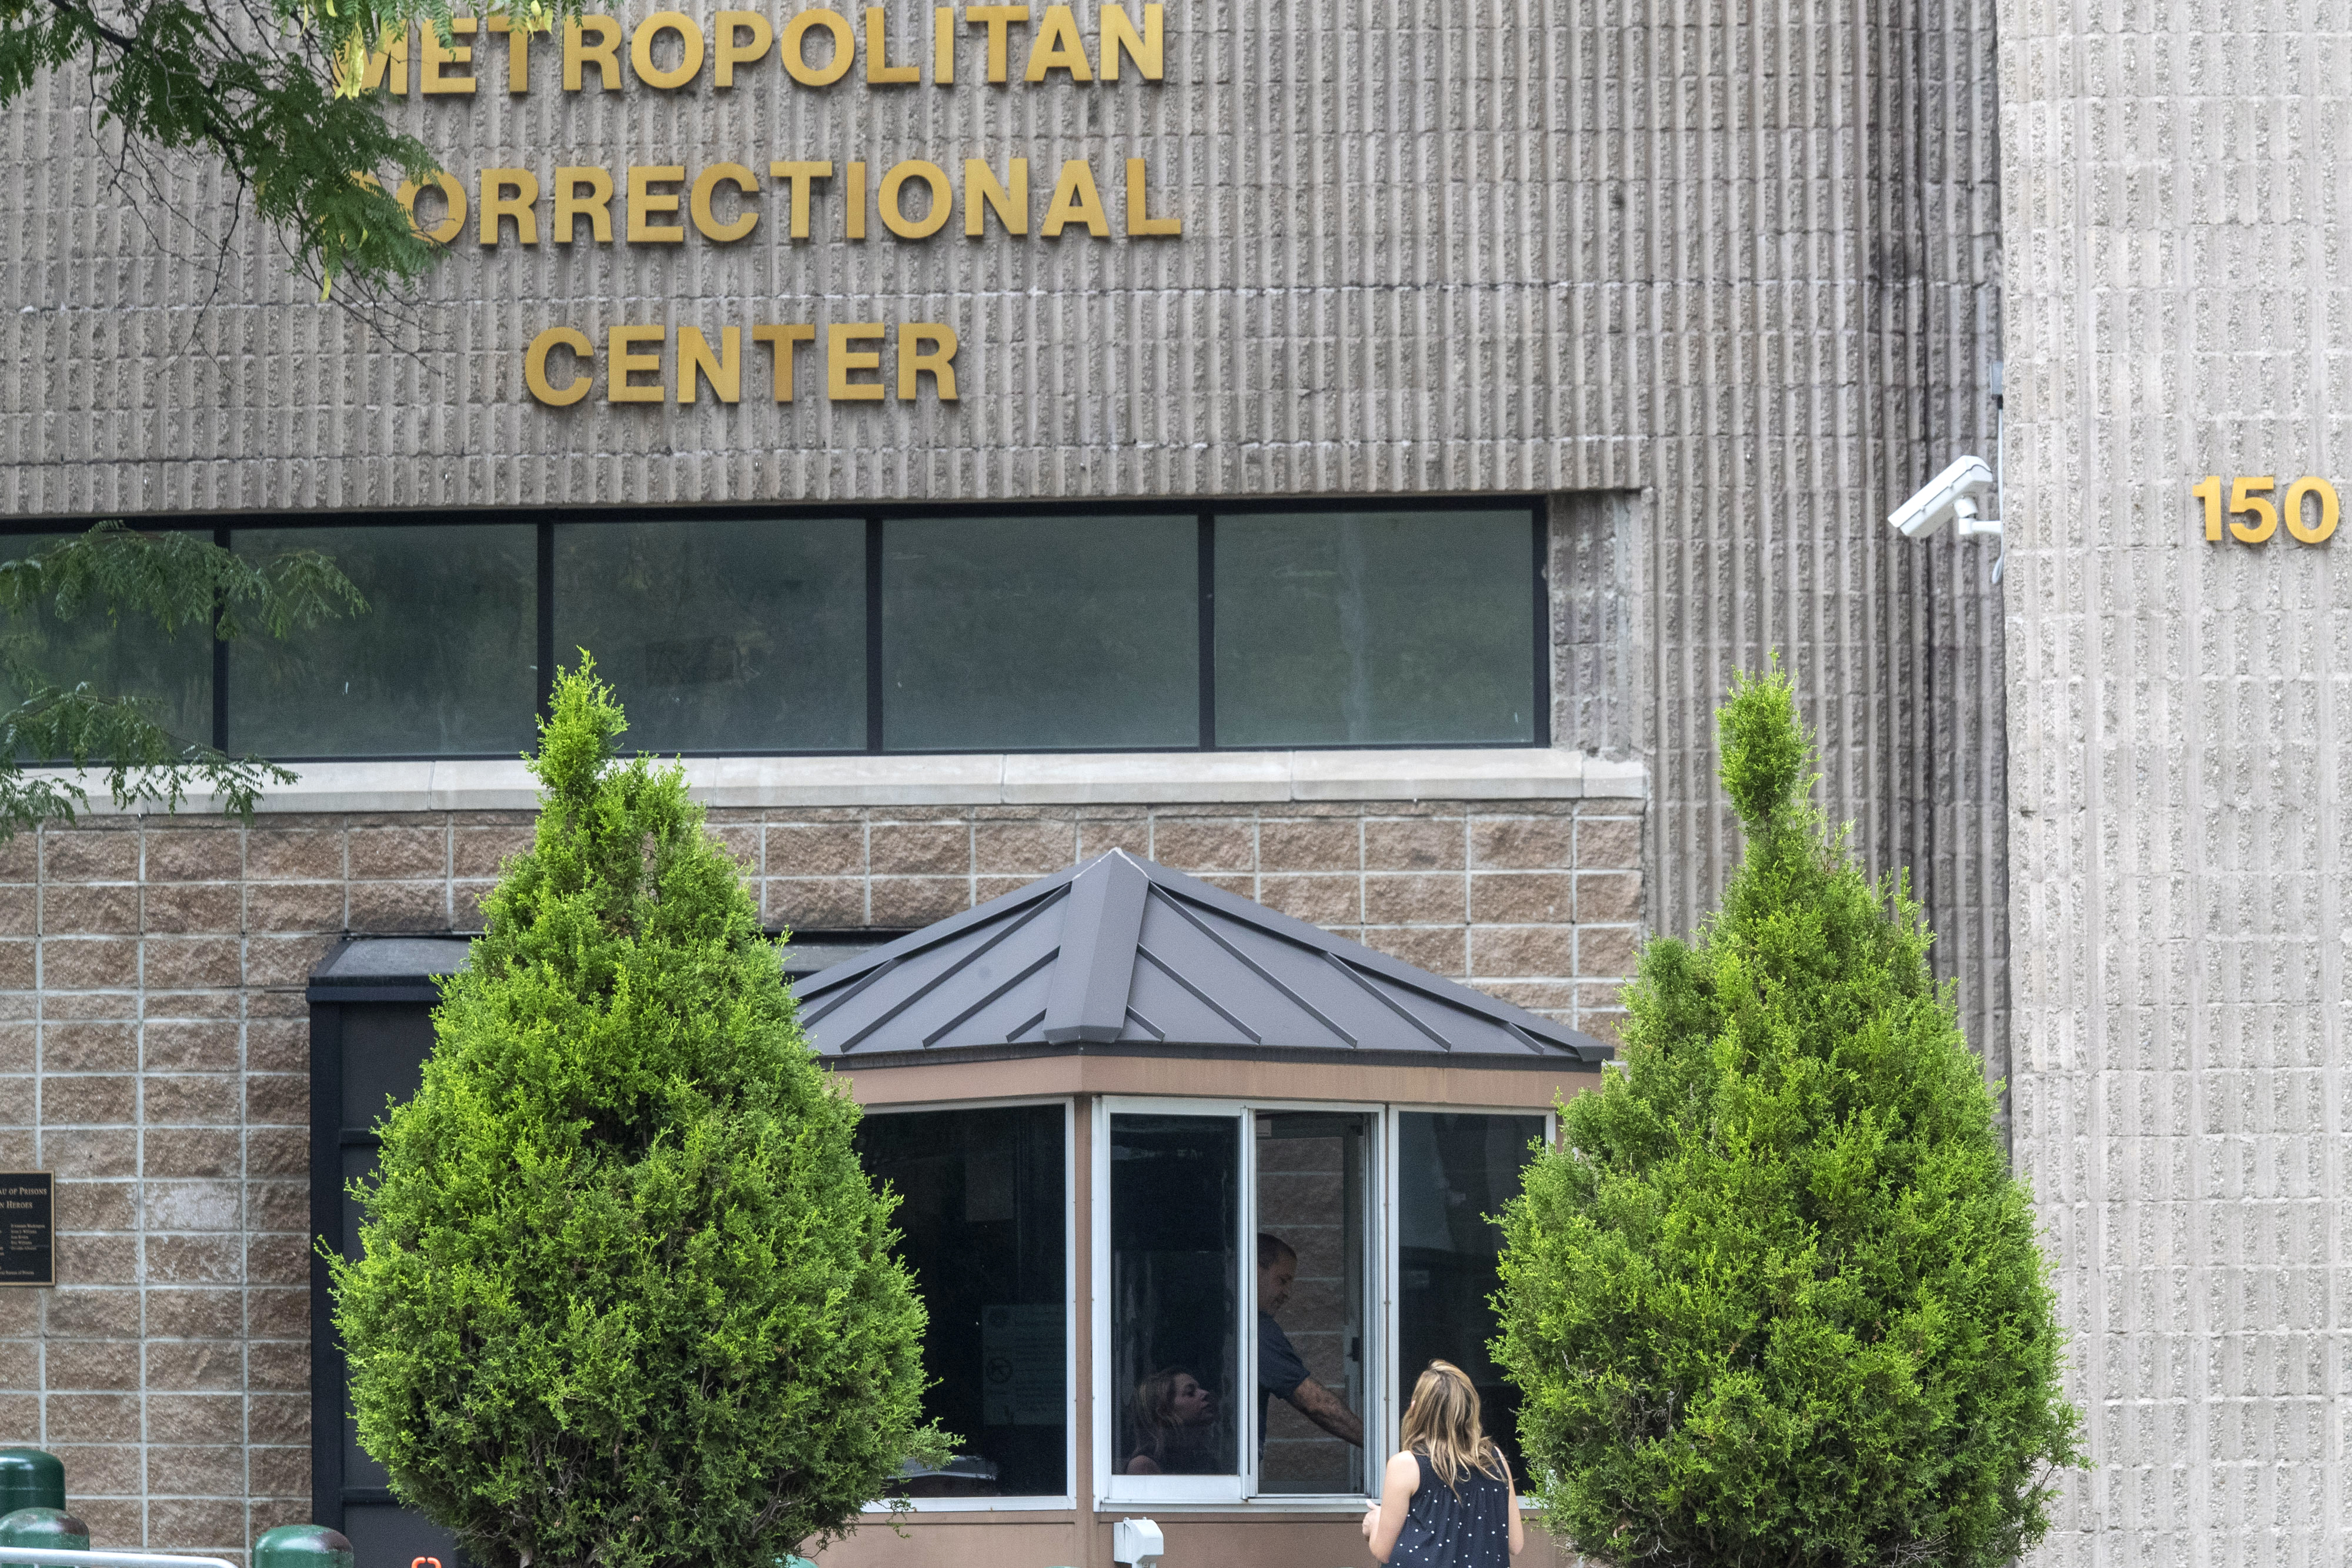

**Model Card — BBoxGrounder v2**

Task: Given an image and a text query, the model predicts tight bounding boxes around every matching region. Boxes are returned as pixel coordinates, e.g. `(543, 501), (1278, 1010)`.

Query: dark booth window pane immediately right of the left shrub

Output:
(858, 1105), (1070, 1497)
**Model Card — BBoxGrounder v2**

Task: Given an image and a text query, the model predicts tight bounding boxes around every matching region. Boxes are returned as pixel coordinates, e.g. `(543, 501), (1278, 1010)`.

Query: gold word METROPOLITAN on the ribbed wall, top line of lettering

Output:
(362, 5), (1167, 99)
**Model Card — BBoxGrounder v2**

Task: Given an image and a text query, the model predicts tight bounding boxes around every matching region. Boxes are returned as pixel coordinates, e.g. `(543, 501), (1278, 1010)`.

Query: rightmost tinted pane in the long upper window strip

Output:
(1216, 510), (1536, 745)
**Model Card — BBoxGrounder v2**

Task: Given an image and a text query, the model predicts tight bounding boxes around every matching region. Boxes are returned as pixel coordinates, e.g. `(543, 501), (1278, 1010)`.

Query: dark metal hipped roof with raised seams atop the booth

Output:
(795, 848), (1609, 1069)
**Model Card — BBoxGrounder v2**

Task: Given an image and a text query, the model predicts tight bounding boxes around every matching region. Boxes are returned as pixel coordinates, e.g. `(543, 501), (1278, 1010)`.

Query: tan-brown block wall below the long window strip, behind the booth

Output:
(0, 801), (1642, 1554)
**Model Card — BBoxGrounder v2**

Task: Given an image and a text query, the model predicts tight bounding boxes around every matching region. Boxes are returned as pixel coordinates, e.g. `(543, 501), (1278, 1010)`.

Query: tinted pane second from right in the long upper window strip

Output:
(882, 517), (1200, 753)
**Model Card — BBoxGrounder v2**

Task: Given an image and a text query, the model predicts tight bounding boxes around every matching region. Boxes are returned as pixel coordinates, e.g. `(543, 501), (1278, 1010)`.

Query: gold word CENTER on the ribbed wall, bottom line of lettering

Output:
(522, 322), (957, 409)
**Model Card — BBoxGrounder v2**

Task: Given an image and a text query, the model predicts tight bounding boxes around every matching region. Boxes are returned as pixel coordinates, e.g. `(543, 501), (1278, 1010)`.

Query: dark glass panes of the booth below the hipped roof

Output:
(858, 1105), (1543, 1497)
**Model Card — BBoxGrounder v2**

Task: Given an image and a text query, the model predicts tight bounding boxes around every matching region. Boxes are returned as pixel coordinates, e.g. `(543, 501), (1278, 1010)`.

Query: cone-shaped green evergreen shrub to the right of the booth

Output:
(1496, 673), (2082, 1568)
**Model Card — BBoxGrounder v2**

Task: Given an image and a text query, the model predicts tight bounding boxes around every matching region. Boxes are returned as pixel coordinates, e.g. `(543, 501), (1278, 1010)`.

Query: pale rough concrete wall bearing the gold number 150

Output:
(1999, 0), (2352, 1568)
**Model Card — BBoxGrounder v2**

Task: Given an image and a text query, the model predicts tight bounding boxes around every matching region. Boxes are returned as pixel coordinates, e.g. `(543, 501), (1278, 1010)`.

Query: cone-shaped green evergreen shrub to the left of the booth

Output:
(329, 661), (941, 1568)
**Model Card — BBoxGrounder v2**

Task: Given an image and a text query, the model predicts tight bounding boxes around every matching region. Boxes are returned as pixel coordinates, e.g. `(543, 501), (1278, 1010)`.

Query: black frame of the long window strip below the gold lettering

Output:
(0, 492), (1555, 762)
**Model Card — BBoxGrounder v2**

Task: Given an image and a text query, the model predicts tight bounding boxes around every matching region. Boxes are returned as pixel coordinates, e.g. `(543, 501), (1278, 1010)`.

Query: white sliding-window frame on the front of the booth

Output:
(1087, 1095), (1559, 1512)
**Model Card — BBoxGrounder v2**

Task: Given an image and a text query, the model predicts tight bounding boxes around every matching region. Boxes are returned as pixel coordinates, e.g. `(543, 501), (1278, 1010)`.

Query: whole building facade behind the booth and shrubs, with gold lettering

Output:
(46, 0), (2347, 1563)
